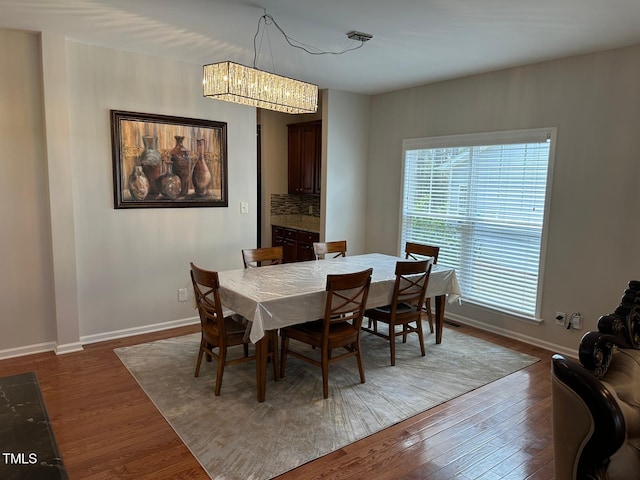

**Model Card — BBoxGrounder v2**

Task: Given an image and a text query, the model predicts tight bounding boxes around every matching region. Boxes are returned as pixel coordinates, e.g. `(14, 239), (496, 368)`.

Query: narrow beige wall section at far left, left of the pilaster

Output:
(0, 29), (55, 354)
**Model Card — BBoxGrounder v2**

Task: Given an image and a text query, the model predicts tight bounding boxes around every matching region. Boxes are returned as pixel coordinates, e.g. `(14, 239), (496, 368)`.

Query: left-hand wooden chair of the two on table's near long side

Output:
(280, 268), (373, 398)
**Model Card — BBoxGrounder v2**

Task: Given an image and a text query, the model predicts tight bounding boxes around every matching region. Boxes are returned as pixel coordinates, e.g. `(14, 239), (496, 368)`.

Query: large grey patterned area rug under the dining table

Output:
(115, 328), (538, 480)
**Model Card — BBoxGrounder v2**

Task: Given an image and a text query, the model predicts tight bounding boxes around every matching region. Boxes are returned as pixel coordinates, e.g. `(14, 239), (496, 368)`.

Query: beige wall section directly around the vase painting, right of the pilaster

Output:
(67, 42), (257, 337)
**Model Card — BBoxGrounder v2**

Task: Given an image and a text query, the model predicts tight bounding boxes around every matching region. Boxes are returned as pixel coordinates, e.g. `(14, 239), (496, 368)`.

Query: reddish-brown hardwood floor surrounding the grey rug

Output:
(0, 326), (553, 480)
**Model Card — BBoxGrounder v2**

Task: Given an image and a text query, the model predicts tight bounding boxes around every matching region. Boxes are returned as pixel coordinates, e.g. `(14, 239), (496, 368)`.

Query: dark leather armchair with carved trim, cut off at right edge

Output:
(551, 282), (640, 480)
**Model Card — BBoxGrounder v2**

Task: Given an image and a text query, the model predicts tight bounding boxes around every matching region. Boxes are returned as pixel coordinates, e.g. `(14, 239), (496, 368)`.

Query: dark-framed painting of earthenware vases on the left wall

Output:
(111, 110), (228, 208)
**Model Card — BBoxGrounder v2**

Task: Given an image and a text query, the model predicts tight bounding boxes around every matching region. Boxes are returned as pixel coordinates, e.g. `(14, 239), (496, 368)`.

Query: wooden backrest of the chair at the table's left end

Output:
(191, 262), (225, 335)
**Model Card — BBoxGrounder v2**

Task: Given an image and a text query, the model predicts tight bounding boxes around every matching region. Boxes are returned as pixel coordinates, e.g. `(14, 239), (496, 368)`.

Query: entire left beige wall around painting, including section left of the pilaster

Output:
(0, 30), (257, 357)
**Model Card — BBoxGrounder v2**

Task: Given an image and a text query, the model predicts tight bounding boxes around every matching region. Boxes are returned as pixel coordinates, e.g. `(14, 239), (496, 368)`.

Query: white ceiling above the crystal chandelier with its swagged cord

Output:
(0, 0), (640, 94)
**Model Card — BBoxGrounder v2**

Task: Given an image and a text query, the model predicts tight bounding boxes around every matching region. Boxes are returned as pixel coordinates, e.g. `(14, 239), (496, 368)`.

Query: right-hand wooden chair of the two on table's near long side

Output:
(362, 260), (432, 365)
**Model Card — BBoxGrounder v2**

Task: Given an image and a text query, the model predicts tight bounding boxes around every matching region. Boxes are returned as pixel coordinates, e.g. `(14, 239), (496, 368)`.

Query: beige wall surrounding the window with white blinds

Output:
(367, 46), (640, 353)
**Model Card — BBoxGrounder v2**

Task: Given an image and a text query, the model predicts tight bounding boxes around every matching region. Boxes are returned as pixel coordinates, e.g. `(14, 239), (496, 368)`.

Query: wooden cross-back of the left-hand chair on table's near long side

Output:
(324, 268), (373, 333)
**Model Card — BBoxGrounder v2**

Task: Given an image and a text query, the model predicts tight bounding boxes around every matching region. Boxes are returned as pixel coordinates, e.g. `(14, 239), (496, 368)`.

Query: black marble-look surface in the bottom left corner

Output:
(0, 372), (68, 480)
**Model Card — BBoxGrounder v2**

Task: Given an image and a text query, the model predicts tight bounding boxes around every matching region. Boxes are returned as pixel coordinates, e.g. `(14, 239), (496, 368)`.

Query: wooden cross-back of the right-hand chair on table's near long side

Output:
(391, 259), (433, 311)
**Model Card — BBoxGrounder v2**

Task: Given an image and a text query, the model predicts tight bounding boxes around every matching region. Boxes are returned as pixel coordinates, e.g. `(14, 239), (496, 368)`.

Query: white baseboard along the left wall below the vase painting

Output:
(0, 317), (200, 360)
